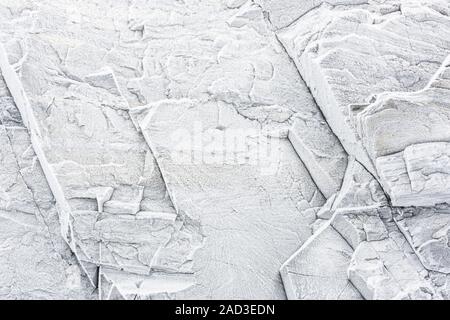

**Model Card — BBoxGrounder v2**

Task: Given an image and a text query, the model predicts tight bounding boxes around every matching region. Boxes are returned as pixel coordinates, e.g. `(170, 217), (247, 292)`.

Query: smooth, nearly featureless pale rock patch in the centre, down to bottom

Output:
(134, 99), (323, 299)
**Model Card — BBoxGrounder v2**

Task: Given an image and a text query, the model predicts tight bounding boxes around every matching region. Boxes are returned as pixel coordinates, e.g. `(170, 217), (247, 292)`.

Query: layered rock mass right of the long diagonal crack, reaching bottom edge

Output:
(268, 0), (450, 299)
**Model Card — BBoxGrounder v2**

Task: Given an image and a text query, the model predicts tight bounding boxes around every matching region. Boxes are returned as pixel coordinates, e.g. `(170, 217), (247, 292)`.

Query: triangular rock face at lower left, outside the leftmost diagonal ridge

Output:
(0, 71), (95, 300)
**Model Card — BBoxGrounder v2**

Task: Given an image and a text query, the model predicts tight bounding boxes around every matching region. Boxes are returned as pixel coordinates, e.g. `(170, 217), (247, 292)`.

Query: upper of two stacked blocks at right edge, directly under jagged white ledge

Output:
(357, 57), (450, 163)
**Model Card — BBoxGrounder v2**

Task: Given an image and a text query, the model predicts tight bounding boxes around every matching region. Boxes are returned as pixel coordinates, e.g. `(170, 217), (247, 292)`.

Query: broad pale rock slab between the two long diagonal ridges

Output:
(1, 1), (346, 298)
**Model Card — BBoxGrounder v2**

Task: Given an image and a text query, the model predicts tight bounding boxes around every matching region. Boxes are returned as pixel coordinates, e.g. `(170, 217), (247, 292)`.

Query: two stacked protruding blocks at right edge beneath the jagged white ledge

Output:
(370, 59), (450, 206)
